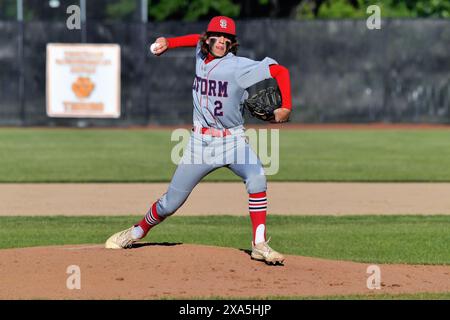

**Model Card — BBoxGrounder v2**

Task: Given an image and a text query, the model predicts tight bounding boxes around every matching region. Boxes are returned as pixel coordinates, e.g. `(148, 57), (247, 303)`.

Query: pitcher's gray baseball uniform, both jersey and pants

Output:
(152, 44), (277, 217)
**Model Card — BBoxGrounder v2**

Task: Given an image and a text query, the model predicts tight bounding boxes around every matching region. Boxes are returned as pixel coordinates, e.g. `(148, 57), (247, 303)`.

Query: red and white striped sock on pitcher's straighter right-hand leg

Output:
(248, 191), (267, 244)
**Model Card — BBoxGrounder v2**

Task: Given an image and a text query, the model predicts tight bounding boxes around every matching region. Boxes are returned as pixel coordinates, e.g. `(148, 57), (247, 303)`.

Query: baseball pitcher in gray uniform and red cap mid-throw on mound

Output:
(105, 16), (292, 264)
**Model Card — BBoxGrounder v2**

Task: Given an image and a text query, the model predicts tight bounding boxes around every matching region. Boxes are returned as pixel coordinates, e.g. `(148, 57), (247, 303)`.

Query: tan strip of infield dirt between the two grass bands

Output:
(0, 182), (450, 216)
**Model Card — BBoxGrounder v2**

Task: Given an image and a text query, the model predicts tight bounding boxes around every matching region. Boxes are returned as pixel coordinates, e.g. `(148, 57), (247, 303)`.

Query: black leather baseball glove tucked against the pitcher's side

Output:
(243, 87), (281, 121)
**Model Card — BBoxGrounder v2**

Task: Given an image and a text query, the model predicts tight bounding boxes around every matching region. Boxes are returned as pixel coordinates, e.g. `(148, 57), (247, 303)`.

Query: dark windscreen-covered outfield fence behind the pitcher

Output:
(0, 19), (450, 126)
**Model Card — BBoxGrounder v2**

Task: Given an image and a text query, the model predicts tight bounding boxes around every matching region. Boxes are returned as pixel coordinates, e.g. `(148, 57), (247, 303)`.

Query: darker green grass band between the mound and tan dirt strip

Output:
(0, 216), (450, 264)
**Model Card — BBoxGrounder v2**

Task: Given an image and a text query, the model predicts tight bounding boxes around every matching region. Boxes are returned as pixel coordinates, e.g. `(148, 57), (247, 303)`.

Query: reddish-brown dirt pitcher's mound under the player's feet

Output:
(0, 243), (450, 299)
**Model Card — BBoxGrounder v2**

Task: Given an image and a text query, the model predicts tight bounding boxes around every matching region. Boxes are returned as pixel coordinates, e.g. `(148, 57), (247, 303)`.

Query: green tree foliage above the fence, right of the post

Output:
(145, 0), (450, 21)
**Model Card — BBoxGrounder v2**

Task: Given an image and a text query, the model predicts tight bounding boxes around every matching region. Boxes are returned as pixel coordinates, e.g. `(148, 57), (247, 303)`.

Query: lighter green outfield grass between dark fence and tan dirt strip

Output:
(0, 128), (450, 182)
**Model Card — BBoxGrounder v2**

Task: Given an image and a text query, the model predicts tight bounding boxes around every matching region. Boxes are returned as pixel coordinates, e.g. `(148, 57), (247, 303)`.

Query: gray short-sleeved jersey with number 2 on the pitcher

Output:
(192, 42), (277, 129)
